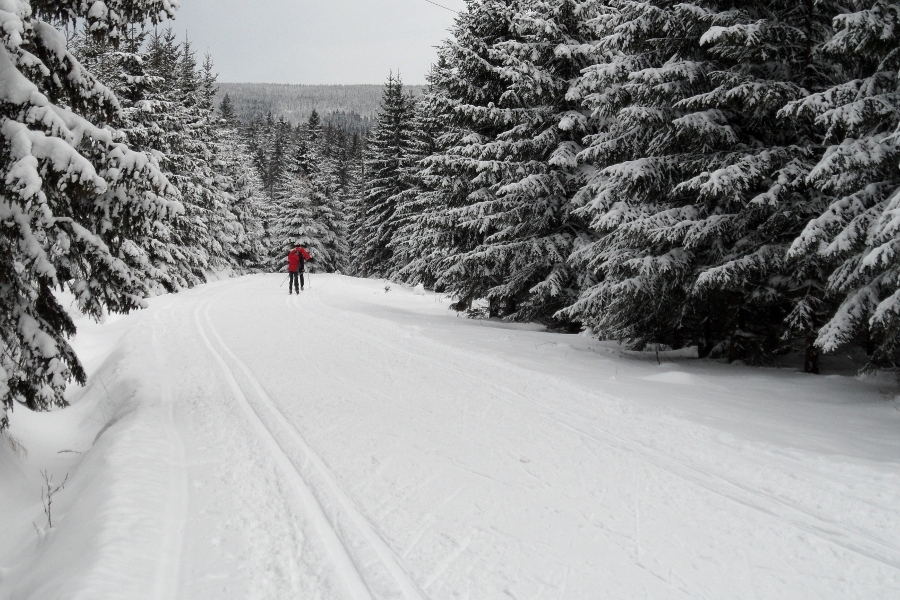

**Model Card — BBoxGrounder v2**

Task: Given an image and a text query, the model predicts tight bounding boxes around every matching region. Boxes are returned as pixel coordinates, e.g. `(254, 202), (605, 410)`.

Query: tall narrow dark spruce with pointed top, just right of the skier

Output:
(364, 73), (412, 276)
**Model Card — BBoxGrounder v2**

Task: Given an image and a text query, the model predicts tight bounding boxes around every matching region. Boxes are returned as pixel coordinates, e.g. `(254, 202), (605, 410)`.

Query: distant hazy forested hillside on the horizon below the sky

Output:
(216, 83), (423, 125)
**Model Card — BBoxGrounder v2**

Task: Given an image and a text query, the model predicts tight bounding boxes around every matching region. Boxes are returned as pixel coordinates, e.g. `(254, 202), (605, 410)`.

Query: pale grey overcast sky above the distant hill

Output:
(165, 0), (465, 84)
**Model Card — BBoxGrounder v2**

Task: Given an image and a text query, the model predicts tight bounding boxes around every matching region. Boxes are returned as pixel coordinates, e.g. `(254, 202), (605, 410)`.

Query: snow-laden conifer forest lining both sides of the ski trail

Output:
(7, 0), (900, 426)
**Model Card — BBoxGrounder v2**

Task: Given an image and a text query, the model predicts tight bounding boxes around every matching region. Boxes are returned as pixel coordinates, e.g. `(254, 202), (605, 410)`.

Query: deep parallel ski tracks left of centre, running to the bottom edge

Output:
(194, 301), (425, 600)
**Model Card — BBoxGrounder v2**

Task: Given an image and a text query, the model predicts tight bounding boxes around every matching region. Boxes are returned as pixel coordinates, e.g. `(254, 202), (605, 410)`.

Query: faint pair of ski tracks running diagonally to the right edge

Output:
(298, 290), (900, 569)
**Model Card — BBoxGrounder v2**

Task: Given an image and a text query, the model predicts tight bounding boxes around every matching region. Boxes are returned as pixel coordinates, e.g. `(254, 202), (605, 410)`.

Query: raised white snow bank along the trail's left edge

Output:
(0, 296), (187, 600)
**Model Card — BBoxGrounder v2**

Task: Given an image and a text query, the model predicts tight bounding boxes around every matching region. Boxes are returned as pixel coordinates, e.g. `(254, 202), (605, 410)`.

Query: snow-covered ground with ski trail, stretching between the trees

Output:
(0, 275), (900, 600)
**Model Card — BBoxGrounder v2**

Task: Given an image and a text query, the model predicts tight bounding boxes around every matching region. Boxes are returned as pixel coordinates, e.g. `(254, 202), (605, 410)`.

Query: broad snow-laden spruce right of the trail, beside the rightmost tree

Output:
(566, 1), (835, 370)
